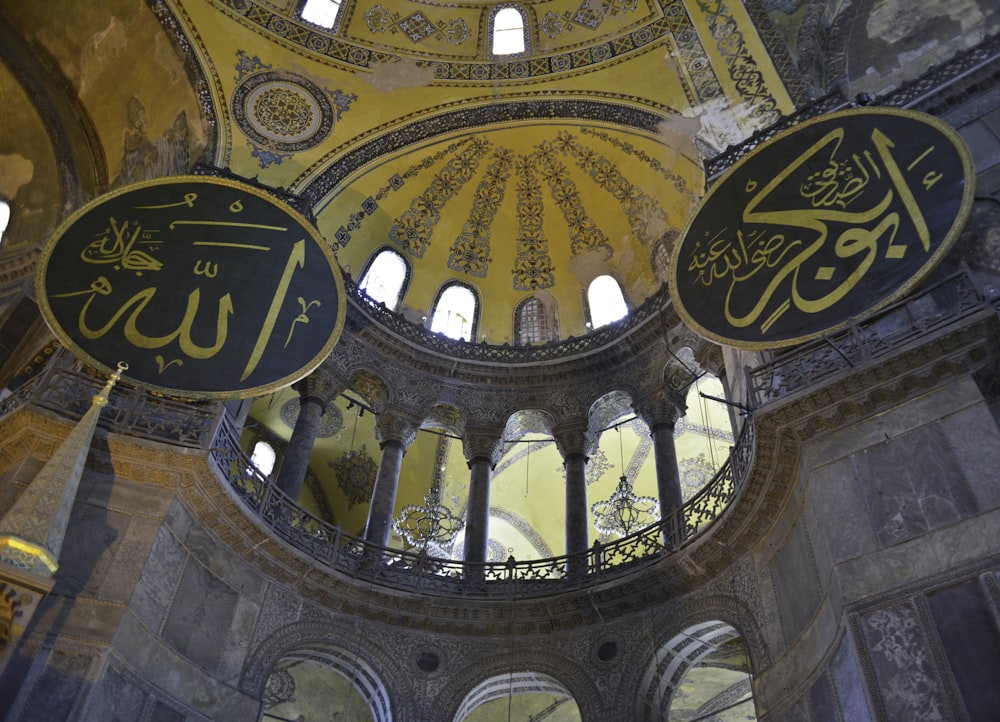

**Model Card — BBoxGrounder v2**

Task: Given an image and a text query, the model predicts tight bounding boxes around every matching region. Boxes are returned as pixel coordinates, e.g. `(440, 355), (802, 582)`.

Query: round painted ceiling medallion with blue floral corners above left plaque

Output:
(232, 50), (357, 168)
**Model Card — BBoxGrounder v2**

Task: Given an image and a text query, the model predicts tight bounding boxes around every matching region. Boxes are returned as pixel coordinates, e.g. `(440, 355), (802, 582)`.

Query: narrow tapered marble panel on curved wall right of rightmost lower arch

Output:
(772, 523), (822, 639)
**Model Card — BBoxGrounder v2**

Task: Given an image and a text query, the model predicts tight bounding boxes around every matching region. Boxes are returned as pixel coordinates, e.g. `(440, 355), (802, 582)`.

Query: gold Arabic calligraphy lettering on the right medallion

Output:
(687, 127), (942, 334)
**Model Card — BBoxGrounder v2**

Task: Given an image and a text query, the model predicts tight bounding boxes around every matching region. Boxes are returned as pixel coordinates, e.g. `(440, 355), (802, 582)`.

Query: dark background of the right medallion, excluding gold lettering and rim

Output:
(671, 108), (974, 348)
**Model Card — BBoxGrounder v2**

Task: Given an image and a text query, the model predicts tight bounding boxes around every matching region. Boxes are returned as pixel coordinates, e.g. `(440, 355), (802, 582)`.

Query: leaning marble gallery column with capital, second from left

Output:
(365, 409), (419, 547)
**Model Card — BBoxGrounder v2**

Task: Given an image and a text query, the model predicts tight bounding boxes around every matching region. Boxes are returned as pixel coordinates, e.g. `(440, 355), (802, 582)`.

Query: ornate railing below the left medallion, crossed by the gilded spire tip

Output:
(0, 349), (224, 449)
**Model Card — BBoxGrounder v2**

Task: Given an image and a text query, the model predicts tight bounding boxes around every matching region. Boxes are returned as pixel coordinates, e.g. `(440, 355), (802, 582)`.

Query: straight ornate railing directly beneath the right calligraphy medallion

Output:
(749, 272), (992, 408)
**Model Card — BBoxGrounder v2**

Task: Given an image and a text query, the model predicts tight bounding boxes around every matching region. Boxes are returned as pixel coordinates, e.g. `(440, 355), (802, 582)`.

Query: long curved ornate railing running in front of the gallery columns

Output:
(209, 404), (754, 598)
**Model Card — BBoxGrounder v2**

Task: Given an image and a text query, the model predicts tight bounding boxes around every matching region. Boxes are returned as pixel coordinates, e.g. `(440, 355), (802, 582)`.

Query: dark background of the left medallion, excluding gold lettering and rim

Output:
(38, 177), (346, 398)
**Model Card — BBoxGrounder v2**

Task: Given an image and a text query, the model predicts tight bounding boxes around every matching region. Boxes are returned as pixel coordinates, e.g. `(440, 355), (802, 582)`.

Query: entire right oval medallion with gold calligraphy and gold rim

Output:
(670, 108), (975, 349)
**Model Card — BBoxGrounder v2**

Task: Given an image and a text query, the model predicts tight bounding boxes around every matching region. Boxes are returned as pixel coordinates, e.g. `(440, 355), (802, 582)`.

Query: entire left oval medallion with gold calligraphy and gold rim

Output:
(36, 176), (346, 398)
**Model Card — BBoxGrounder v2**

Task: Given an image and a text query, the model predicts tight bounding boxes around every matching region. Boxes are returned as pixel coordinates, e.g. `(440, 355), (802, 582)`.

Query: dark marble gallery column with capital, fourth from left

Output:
(552, 421), (597, 573)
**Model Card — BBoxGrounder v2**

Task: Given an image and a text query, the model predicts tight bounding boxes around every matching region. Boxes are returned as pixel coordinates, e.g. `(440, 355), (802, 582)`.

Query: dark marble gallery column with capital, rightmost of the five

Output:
(633, 388), (687, 546)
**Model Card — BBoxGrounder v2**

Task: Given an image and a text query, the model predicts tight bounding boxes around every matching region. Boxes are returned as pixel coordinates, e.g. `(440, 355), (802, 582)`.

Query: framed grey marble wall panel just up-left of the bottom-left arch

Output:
(163, 561), (237, 670)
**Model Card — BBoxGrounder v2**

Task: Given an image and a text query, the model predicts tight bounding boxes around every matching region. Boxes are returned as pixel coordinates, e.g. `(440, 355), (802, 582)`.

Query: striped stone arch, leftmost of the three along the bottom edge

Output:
(239, 620), (406, 722)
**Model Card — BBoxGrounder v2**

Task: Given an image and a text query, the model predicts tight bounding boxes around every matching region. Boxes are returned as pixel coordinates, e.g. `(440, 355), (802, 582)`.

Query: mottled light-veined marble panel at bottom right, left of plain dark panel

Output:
(860, 604), (951, 722)
